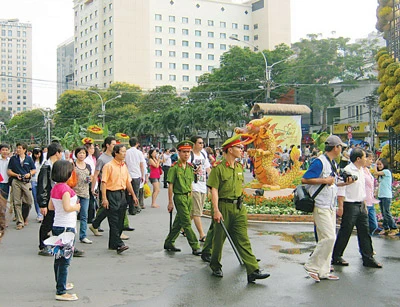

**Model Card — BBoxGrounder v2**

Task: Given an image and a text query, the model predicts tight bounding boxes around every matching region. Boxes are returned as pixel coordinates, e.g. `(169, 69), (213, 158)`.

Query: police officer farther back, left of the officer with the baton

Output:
(164, 141), (201, 256)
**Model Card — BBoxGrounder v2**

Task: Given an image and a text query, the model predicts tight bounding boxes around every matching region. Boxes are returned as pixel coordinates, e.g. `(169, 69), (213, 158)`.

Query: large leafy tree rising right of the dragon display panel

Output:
(285, 34), (378, 128)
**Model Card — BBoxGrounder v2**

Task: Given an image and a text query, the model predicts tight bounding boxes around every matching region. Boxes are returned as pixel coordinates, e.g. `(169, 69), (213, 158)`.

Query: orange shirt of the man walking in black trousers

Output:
(101, 159), (132, 191)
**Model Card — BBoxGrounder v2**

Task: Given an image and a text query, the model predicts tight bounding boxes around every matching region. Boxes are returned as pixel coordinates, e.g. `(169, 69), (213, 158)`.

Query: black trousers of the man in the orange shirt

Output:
(105, 190), (127, 249)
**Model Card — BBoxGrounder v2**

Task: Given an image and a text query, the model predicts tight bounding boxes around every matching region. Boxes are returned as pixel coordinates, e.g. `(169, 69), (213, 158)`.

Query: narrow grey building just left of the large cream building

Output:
(57, 37), (74, 96)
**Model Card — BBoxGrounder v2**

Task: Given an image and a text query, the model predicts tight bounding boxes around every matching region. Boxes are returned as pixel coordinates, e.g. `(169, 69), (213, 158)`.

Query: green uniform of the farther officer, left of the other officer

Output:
(164, 160), (200, 250)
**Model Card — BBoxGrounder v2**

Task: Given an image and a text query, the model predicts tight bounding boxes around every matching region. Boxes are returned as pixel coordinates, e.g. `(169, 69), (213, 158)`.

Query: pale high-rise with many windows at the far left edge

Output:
(0, 19), (32, 114)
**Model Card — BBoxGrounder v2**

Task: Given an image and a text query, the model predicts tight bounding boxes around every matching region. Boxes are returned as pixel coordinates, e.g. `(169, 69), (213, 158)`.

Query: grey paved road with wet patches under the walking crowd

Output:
(0, 174), (400, 307)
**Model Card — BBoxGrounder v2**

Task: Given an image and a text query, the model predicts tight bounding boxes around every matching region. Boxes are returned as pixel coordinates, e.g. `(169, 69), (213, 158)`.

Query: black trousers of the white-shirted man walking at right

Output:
(332, 202), (373, 261)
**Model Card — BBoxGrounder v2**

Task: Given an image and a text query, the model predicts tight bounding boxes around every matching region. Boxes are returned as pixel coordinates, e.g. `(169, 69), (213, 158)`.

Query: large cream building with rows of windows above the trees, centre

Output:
(74, 0), (291, 91)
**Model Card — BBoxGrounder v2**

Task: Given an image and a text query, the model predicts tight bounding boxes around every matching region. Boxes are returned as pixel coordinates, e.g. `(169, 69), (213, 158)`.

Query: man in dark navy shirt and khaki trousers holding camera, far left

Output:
(7, 143), (36, 230)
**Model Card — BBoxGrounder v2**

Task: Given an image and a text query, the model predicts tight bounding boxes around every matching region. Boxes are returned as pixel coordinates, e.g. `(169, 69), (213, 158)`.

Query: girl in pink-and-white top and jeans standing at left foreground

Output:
(49, 160), (81, 301)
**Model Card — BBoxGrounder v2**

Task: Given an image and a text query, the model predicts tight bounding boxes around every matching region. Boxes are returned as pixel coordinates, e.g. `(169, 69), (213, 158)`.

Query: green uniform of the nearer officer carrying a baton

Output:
(207, 159), (258, 274)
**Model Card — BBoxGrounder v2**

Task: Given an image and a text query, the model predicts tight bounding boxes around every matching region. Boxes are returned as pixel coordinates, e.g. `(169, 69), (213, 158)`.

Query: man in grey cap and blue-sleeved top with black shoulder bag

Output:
(301, 135), (346, 282)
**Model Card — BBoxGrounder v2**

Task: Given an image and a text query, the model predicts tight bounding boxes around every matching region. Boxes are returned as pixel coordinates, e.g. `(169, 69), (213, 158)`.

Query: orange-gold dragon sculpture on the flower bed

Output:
(235, 117), (301, 190)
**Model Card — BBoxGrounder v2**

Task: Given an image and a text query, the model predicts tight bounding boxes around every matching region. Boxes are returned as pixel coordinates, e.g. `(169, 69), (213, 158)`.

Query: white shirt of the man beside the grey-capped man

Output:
(338, 163), (367, 202)
